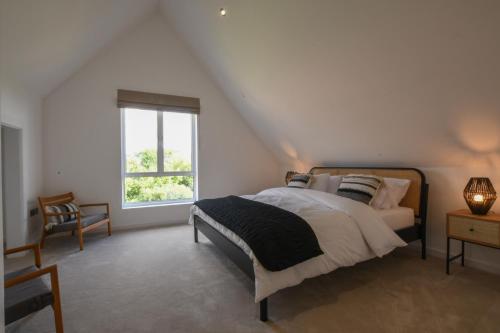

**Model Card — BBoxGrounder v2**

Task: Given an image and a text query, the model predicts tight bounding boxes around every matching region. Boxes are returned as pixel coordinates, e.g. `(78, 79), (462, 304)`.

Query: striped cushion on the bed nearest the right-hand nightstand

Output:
(337, 174), (383, 205)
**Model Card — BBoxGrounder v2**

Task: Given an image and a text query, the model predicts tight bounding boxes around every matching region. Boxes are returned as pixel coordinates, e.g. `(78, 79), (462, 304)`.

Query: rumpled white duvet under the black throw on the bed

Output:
(189, 187), (406, 302)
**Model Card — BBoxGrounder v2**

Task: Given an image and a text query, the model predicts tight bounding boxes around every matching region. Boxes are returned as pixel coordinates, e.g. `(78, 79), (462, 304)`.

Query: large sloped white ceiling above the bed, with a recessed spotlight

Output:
(161, 0), (500, 168)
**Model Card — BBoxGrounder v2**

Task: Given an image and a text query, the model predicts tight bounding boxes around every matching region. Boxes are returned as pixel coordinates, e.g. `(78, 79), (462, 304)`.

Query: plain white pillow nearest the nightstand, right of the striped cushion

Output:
(372, 178), (411, 209)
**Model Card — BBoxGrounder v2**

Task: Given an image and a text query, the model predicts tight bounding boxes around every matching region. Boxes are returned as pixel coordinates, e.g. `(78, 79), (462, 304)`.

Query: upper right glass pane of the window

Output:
(163, 112), (193, 172)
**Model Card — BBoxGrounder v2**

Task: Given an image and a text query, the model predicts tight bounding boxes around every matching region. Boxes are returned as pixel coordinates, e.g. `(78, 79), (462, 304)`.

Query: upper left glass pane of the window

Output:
(125, 109), (158, 172)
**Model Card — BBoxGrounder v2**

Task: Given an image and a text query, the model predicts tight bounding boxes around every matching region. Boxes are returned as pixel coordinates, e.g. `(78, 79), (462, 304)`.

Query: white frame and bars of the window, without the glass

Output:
(120, 107), (198, 209)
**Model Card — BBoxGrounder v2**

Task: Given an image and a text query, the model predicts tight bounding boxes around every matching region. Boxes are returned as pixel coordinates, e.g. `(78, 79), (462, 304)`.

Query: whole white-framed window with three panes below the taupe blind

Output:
(121, 108), (197, 207)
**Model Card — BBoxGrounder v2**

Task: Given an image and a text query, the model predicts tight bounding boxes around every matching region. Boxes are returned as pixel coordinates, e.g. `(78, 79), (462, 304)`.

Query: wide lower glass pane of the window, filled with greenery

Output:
(125, 176), (194, 203)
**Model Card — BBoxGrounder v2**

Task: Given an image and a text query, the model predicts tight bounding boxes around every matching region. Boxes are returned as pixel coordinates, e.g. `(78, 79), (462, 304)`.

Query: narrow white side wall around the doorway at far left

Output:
(1, 81), (43, 246)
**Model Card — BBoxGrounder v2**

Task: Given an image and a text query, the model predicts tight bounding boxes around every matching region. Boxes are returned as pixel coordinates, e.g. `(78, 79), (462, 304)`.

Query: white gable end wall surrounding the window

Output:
(43, 16), (280, 227)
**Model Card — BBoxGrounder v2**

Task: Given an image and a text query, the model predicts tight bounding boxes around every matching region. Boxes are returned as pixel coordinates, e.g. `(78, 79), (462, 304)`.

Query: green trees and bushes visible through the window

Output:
(125, 149), (194, 203)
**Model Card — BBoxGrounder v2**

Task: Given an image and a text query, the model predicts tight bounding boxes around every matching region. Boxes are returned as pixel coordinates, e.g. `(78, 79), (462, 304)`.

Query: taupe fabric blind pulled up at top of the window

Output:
(117, 89), (200, 114)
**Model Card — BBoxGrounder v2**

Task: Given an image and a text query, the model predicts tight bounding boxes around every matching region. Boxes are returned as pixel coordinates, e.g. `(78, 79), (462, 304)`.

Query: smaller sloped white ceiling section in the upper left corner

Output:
(0, 0), (158, 97)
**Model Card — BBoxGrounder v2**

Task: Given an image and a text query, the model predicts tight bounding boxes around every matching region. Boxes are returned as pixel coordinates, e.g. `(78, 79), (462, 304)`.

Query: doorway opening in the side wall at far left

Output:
(1, 124), (26, 248)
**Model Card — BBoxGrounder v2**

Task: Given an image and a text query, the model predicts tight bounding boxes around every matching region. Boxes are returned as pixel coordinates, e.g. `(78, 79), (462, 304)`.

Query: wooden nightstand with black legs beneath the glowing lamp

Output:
(446, 209), (500, 274)
